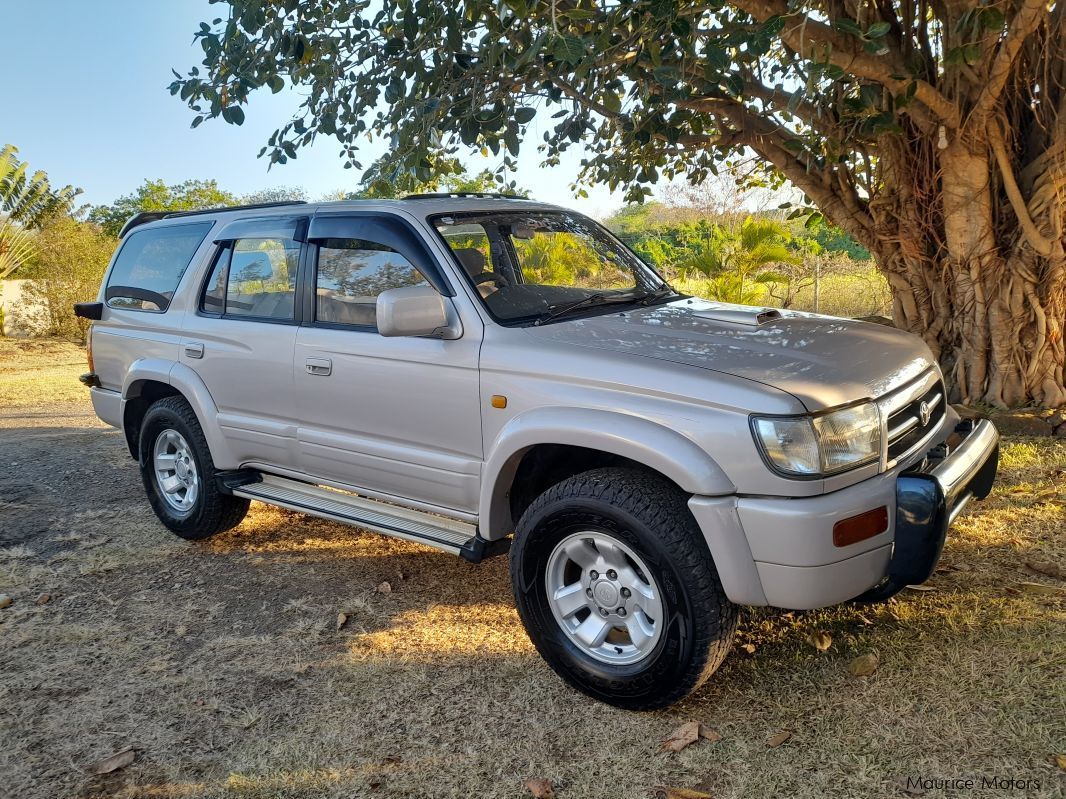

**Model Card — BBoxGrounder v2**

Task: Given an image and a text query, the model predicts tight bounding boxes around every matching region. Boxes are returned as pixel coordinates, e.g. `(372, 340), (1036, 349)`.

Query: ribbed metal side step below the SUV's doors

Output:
(231, 473), (511, 562)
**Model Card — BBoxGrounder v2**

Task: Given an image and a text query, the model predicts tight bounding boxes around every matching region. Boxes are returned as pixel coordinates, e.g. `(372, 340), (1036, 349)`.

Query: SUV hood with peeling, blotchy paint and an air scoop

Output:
(527, 298), (933, 411)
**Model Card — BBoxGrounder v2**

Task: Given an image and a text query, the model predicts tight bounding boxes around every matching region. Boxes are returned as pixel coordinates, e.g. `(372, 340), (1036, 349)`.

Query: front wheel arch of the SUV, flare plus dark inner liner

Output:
(480, 408), (736, 540)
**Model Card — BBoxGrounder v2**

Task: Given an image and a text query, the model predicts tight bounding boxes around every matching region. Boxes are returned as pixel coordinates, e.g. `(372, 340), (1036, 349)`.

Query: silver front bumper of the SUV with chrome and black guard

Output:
(689, 421), (999, 609)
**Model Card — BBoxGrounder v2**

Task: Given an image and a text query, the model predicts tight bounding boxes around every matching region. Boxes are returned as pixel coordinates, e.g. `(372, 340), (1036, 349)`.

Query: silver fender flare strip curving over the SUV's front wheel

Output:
(479, 407), (737, 540)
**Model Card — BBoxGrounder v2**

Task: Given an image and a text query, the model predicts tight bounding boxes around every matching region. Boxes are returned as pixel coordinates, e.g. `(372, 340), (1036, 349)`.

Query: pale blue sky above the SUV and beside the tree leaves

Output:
(0, 0), (621, 215)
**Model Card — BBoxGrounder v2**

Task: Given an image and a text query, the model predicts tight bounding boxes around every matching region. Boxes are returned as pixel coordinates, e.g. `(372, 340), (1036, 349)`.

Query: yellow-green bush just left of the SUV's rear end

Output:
(19, 216), (117, 341)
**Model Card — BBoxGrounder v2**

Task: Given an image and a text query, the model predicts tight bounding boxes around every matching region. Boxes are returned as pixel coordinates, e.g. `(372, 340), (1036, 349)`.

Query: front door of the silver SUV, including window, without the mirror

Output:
(293, 214), (483, 513)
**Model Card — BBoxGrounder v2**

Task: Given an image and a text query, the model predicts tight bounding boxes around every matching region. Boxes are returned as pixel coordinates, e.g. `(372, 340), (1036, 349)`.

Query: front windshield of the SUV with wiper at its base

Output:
(433, 211), (674, 324)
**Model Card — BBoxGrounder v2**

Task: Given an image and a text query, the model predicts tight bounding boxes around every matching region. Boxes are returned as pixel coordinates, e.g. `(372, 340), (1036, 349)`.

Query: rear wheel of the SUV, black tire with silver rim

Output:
(138, 396), (248, 541)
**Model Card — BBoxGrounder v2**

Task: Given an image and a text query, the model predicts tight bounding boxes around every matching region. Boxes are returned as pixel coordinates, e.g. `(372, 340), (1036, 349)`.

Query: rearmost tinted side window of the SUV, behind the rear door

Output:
(104, 222), (213, 311)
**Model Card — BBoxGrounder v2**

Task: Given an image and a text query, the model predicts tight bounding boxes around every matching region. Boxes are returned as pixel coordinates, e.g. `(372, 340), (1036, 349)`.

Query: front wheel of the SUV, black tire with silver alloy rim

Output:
(511, 468), (738, 711)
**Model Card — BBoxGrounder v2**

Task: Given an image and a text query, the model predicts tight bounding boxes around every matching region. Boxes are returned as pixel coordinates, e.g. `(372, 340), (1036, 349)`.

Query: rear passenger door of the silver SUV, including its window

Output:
(180, 217), (307, 469)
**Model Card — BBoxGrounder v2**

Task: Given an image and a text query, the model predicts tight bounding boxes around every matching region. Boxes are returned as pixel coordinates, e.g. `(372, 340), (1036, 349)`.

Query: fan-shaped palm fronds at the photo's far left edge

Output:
(0, 144), (81, 280)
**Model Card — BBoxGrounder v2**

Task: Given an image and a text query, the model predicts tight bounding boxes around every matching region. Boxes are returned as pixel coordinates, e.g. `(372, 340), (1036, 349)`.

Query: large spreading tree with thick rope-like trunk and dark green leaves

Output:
(171, 0), (1066, 406)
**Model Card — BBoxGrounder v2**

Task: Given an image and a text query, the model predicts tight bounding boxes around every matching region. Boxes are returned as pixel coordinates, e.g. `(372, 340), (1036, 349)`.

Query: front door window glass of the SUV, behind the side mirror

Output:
(314, 239), (430, 327)
